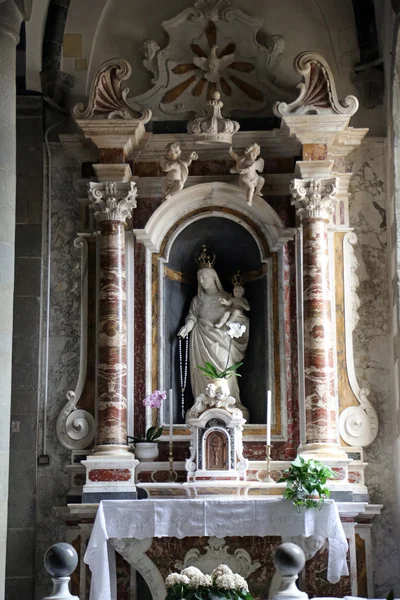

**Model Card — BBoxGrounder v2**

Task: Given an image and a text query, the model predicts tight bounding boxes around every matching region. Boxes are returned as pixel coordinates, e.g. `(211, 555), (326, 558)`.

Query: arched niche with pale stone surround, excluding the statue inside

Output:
(134, 183), (295, 432)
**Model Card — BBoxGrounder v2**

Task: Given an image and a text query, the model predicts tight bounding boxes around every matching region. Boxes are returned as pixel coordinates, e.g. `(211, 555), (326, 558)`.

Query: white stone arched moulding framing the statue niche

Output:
(133, 182), (296, 441)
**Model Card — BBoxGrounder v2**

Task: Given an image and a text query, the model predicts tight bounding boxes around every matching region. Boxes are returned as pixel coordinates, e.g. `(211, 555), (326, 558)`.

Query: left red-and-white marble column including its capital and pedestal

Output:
(82, 181), (138, 503)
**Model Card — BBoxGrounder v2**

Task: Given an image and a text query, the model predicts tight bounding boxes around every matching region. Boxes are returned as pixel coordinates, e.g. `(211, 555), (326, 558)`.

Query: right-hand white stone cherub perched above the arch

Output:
(229, 144), (265, 206)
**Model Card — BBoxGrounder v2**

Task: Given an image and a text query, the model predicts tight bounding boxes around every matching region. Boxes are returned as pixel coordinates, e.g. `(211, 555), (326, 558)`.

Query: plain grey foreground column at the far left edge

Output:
(0, 0), (30, 598)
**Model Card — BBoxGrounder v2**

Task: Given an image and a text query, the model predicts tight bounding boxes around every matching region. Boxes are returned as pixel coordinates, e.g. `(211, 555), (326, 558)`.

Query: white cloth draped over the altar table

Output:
(84, 498), (348, 600)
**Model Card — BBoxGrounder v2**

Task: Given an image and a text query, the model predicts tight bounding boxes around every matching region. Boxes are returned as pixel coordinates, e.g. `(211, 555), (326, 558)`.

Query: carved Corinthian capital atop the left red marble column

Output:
(89, 181), (137, 223)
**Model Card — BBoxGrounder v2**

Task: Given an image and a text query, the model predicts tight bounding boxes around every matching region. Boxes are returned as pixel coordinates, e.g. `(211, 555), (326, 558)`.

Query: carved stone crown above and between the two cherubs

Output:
(187, 92), (240, 144)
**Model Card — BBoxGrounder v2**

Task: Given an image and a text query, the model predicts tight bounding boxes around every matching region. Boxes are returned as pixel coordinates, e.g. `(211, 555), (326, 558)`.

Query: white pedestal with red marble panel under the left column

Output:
(82, 449), (139, 504)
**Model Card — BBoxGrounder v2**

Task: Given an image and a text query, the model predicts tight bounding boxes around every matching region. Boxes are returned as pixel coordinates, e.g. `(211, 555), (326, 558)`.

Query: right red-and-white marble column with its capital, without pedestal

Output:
(291, 177), (341, 455)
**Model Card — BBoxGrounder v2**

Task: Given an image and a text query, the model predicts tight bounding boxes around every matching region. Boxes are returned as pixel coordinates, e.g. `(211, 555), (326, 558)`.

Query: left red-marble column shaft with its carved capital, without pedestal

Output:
(89, 182), (136, 453)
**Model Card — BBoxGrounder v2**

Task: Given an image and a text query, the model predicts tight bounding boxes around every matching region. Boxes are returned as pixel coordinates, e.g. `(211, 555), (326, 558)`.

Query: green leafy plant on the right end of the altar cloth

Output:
(278, 456), (335, 510)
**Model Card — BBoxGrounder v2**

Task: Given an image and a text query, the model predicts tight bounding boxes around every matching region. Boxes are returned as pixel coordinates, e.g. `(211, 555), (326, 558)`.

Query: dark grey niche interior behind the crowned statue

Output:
(162, 217), (269, 423)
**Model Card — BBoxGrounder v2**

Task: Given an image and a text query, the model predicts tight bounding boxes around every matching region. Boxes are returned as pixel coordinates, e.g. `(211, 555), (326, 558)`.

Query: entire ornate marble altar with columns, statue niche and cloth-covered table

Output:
(51, 0), (381, 600)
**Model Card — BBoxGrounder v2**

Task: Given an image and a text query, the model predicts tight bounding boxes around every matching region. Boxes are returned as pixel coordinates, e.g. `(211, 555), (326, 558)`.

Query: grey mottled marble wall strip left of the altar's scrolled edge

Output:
(35, 144), (80, 599)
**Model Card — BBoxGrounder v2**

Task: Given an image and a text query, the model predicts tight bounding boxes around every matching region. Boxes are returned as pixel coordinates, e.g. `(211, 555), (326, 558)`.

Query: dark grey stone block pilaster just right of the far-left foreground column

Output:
(2, 96), (44, 600)
